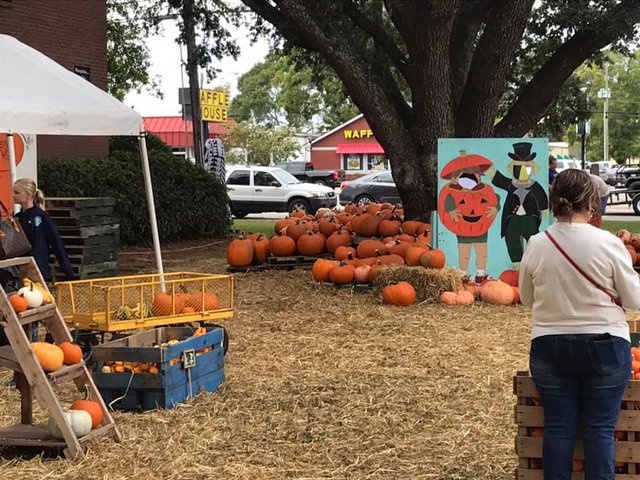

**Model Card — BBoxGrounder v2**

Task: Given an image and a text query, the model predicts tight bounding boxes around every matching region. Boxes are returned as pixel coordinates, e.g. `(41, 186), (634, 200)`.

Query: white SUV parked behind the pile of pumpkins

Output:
(227, 165), (336, 218)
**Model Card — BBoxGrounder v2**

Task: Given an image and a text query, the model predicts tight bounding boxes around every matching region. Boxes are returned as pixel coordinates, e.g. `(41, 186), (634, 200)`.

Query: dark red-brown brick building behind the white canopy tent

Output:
(0, 0), (109, 158)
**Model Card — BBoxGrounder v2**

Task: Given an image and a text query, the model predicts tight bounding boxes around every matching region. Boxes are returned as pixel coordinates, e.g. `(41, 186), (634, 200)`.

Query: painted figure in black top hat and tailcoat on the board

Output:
(492, 142), (549, 269)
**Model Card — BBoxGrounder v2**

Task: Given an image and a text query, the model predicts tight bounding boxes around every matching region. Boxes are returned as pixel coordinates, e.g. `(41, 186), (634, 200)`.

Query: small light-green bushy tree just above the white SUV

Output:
(223, 122), (300, 165)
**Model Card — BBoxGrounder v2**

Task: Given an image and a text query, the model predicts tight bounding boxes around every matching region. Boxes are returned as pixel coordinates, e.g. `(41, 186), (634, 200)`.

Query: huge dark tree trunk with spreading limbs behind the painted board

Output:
(242, 0), (640, 218)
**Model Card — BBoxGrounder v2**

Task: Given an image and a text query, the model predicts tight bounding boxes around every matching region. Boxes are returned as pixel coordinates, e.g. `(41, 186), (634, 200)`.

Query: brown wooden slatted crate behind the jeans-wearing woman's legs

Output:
(513, 372), (640, 480)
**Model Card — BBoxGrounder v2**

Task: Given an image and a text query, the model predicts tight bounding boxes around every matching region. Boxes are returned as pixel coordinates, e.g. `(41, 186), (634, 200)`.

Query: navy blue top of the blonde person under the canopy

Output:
(16, 205), (73, 281)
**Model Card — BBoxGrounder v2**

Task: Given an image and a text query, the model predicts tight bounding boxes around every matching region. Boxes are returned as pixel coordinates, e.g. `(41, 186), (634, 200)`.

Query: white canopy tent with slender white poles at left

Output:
(0, 35), (163, 275)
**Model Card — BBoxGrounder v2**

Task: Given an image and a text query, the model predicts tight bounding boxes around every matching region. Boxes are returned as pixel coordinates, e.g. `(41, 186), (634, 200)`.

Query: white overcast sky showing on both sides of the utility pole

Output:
(124, 20), (269, 117)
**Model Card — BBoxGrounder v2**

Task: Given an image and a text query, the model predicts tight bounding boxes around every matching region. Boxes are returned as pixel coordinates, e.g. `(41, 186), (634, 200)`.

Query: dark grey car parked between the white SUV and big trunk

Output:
(340, 170), (400, 205)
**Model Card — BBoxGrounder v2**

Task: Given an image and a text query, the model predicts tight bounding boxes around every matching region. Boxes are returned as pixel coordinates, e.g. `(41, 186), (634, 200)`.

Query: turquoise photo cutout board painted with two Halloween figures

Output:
(436, 138), (549, 283)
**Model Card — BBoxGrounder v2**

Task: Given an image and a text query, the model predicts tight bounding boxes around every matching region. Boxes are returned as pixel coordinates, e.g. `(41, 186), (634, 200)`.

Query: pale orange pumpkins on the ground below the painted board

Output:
(440, 270), (520, 305)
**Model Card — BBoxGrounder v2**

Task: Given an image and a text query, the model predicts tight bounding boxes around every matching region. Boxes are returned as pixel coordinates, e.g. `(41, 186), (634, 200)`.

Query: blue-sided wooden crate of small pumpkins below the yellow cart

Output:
(93, 327), (224, 410)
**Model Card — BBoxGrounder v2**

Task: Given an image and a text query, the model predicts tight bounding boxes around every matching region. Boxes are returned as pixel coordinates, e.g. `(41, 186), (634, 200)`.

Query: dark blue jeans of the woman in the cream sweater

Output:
(529, 333), (631, 480)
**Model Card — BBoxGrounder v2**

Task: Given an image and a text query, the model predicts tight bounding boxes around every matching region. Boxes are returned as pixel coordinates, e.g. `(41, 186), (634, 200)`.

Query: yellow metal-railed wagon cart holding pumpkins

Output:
(55, 272), (234, 343)
